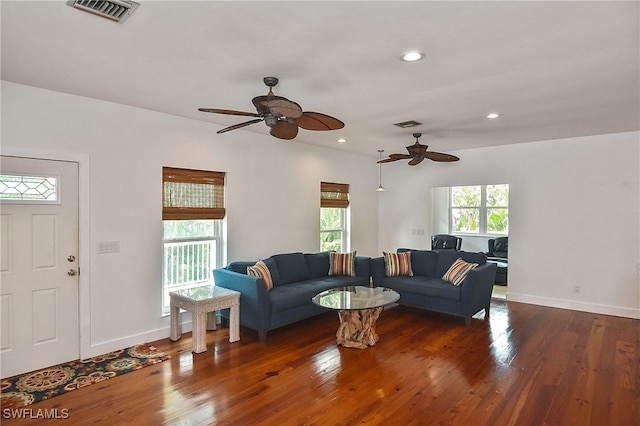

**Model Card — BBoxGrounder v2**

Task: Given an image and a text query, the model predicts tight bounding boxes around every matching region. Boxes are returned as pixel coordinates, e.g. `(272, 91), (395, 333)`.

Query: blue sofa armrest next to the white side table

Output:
(213, 268), (271, 330)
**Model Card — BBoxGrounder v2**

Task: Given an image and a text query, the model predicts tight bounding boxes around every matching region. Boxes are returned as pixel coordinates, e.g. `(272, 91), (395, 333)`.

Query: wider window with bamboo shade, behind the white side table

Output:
(162, 167), (225, 315)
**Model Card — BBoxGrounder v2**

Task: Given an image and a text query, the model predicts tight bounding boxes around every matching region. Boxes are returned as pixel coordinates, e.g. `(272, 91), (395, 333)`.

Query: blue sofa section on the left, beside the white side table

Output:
(213, 252), (370, 341)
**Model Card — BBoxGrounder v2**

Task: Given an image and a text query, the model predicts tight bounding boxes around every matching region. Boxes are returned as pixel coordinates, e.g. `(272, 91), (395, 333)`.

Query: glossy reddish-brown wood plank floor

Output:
(3, 299), (640, 426)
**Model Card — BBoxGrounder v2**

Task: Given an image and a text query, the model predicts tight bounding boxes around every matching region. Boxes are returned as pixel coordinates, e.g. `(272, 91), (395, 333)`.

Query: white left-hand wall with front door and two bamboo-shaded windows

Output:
(1, 81), (378, 357)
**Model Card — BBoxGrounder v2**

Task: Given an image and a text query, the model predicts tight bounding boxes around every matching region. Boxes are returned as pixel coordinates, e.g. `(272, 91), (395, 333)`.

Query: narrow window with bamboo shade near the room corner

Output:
(320, 182), (349, 253)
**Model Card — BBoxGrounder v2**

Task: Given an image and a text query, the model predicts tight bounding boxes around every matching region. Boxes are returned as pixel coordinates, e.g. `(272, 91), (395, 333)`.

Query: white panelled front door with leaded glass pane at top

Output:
(0, 156), (79, 378)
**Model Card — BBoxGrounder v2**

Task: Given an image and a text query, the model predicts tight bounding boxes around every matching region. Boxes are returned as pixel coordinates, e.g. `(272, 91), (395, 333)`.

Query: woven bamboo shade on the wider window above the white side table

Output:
(162, 167), (225, 220)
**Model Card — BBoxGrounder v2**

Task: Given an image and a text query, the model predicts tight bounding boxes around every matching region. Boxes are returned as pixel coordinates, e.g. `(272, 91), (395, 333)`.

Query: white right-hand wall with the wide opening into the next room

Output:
(379, 132), (640, 318)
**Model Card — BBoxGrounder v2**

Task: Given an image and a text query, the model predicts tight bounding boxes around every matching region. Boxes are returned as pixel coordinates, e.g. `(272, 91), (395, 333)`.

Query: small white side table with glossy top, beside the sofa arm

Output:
(169, 285), (240, 353)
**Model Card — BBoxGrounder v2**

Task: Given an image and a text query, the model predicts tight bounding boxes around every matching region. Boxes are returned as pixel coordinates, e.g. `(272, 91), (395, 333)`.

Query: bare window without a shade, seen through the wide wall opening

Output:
(449, 184), (509, 235)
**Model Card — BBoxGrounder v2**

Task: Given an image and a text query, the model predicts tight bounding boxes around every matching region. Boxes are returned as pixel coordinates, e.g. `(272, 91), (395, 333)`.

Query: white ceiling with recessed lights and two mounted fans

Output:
(1, 0), (640, 157)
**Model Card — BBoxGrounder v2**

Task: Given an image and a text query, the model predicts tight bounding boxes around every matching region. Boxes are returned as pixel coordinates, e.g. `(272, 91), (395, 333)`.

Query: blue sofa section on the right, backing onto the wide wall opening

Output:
(371, 249), (496, 326)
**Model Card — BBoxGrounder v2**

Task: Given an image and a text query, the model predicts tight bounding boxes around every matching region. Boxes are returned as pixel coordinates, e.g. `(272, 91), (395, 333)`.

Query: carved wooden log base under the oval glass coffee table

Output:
(336, 307), (382, 349)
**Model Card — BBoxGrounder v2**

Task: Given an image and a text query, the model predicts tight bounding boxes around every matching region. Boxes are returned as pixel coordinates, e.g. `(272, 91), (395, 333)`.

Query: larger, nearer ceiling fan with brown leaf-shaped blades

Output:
(198, 77), (344, 139)
